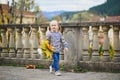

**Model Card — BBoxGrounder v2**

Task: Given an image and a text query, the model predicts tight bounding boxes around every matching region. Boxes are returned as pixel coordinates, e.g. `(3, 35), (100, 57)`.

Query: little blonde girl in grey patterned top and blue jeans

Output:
(46, 20), (68, 76)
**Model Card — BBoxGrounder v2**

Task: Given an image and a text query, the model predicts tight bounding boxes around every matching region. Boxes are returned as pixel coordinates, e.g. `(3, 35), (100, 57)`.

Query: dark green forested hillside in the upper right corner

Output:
(89, 0), (120, 16)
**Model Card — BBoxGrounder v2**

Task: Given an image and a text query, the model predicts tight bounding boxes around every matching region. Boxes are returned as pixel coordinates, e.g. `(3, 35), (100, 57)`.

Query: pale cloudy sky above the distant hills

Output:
(0, 0), (106, 11)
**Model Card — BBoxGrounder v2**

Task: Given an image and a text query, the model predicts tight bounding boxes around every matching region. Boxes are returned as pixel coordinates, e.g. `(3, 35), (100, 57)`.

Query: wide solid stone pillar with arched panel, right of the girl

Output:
(63, 27), (78, 67)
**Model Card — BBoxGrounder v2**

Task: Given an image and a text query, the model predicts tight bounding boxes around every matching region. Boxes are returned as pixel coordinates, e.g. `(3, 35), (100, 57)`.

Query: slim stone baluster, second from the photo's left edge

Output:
(8, 28), (16, 57)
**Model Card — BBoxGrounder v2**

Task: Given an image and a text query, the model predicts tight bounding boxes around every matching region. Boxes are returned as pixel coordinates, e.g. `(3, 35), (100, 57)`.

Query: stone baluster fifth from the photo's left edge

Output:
(31, 27), (39, 59)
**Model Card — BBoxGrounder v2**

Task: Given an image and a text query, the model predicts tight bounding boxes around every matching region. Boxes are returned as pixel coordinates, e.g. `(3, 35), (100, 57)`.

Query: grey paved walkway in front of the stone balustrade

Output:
(0, 66), (120, 80)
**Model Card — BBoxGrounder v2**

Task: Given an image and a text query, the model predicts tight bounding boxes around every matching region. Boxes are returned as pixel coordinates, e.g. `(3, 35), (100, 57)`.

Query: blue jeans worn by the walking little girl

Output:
(52, 52), (60, 72)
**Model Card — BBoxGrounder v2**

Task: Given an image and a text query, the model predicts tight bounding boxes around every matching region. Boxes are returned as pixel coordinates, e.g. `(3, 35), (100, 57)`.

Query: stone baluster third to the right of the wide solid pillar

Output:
(102, 26), (110, 61)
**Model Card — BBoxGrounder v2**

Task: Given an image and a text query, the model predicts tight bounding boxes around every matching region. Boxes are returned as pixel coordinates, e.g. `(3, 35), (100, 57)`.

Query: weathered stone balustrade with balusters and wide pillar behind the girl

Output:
(0, 22), (120, 71)
